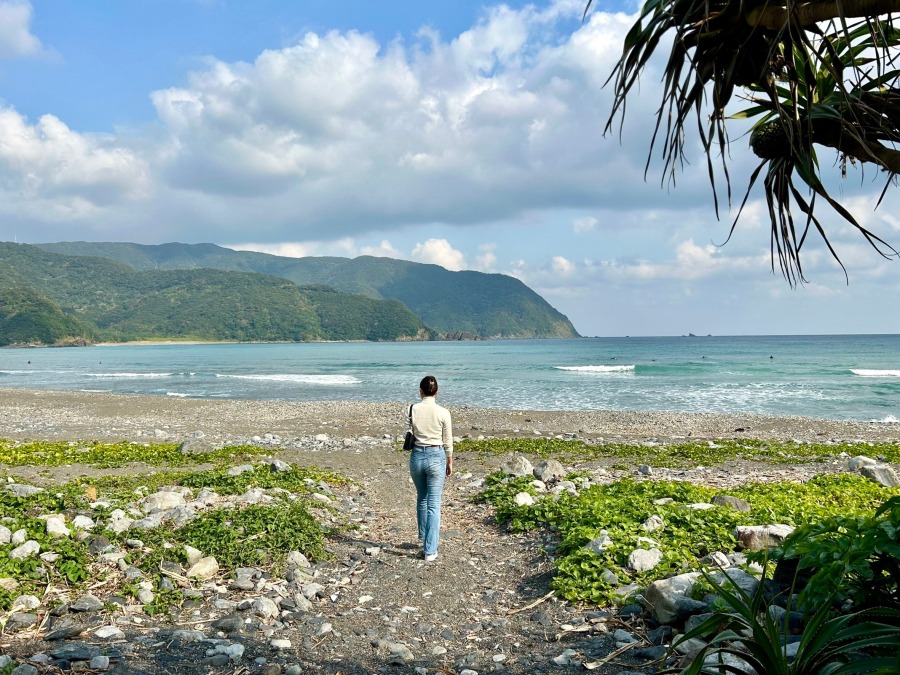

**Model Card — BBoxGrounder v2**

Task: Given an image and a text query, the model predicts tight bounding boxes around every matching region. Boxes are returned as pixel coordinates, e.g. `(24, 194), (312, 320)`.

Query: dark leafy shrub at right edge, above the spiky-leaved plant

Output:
(770, 497), (900, 609)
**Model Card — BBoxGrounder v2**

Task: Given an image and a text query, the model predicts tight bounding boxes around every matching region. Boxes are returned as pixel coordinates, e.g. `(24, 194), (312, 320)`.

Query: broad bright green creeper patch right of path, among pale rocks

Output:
(478, 472), (900, 604)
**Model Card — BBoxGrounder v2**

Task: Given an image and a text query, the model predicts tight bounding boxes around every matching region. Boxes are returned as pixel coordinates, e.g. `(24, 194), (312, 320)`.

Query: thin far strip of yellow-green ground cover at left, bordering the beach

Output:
(0, 439), (267, 469)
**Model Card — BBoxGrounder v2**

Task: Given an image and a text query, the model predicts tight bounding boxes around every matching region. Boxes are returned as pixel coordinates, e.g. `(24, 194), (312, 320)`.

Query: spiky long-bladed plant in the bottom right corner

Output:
(662, 564), (900, 675)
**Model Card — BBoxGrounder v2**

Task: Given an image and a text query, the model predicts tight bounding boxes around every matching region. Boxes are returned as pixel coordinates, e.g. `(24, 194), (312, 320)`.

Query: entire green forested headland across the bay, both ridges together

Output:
(0, 242), (579, 346)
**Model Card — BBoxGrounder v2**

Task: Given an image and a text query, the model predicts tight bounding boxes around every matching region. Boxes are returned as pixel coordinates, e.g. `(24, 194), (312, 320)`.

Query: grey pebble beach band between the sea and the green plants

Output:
(0, 388), (900, 444)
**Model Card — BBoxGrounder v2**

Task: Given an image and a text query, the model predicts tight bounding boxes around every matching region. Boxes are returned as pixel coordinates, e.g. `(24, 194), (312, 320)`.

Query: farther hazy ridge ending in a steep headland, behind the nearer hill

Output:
(38, 242), (579, 338)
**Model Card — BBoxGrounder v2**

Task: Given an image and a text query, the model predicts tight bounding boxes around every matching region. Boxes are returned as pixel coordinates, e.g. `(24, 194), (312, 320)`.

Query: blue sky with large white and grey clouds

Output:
(0, 0), (900, 336)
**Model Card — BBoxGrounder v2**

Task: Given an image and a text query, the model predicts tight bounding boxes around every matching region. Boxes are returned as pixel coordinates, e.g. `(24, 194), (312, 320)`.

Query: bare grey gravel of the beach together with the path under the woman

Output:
(0, 389), (900, 675)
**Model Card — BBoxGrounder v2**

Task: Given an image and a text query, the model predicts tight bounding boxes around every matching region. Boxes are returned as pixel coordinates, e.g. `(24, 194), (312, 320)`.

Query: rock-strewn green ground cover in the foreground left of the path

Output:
(0, 464), (350, 611)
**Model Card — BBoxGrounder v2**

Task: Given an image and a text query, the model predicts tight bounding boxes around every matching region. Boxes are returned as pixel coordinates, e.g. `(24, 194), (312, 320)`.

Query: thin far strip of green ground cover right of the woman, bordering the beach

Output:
(456, 438), (900, 468)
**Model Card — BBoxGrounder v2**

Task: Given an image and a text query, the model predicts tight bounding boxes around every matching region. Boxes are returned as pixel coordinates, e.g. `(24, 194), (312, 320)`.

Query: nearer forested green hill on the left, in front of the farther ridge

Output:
(0, 243), (433, 346)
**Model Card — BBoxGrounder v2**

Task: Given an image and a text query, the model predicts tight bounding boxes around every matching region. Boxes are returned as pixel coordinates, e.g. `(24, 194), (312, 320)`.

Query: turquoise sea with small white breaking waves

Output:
(0, 335), (900, 423)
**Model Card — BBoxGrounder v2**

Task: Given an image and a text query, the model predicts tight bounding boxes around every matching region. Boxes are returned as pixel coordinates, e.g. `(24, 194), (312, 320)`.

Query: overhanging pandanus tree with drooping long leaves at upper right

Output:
(585, 0), (900, 285)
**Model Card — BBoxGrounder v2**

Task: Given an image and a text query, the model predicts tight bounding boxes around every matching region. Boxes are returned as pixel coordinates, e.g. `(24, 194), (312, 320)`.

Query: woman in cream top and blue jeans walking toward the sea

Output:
(409, 375), (453, 562)
